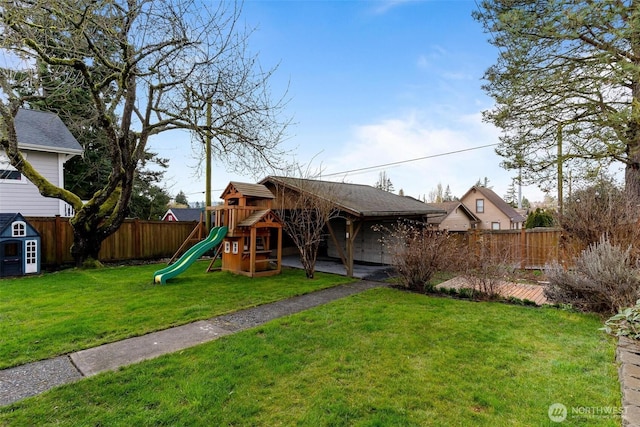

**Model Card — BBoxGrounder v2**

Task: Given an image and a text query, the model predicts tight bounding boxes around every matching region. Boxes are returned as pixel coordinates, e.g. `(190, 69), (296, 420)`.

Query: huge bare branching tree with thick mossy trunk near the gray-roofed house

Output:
(0, 0), (288, 264)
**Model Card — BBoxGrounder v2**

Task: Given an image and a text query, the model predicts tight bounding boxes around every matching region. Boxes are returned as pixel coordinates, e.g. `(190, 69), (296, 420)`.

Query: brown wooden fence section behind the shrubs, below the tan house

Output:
(460, 228), (581, 269)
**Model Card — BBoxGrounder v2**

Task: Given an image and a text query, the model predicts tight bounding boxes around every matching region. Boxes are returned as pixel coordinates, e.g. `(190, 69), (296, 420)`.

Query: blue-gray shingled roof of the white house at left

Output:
(15, 108), (82, 154)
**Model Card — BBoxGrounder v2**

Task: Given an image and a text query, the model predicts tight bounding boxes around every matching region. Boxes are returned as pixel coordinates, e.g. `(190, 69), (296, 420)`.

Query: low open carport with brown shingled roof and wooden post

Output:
(260, 176), (445, 275)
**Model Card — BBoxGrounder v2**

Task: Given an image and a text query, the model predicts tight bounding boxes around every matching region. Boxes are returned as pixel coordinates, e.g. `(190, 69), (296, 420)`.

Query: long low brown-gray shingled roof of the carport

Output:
(260, 176), (444, 217)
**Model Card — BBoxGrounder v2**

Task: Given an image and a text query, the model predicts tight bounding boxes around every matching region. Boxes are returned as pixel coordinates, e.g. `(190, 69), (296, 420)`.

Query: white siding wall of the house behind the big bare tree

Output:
(0, 151), (61, 216)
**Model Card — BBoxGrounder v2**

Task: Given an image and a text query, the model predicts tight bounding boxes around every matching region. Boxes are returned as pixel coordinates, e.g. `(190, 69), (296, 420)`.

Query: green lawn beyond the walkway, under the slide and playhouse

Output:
(0, 261), (356, 368)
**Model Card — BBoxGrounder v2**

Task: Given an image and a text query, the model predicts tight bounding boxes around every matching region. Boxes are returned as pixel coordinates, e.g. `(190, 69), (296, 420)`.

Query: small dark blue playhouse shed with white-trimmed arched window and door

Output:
(0, 213), (40, 277)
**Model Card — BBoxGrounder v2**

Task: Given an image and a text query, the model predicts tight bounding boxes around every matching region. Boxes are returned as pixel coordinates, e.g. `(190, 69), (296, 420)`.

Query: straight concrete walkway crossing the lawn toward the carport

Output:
(0, 281), (386, 406)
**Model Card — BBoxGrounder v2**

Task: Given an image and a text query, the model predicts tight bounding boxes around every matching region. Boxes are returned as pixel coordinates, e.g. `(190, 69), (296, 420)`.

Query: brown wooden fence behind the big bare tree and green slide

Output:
(27, 216), (197, 267)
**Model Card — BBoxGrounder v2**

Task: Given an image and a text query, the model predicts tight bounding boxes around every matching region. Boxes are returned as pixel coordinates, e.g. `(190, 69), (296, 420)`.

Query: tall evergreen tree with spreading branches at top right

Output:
(474, 0), (640, 199)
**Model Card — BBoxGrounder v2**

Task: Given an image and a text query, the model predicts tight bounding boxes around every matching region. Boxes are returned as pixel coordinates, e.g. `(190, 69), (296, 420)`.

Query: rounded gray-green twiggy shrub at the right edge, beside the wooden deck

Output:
(545, 237), (640, 314)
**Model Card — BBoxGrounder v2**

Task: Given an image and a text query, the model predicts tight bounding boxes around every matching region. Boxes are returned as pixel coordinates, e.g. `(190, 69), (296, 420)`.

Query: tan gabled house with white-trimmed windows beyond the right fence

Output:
(460, 185), (525, 230)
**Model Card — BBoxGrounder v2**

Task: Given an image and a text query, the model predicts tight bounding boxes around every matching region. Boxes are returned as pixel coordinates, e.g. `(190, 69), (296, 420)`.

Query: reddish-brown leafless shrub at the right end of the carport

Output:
(376, 221), (459, 292)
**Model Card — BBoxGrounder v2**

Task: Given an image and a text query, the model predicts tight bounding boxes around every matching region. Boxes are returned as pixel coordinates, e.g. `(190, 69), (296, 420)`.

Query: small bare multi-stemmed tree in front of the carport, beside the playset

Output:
(267, 174), (339, 279)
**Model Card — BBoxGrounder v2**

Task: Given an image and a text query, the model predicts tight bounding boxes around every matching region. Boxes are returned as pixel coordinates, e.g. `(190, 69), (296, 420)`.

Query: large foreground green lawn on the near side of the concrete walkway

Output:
(0, 289), (620, 426)
